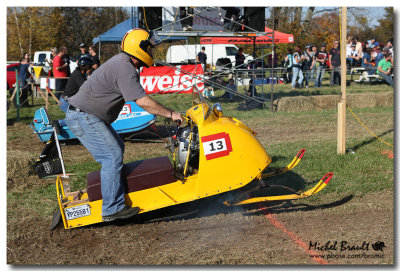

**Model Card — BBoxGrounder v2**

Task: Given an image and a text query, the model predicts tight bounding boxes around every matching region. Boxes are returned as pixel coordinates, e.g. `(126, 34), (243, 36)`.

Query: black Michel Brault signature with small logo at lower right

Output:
(308, 241), (386, 252)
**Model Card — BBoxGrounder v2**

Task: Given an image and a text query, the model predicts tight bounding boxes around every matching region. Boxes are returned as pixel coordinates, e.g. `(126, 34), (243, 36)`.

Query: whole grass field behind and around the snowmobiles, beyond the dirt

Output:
(7, 82), (394, 264)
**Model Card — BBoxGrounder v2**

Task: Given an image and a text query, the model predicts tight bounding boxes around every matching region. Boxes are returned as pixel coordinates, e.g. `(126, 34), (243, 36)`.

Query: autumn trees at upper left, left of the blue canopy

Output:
(7, 7), (129, 61)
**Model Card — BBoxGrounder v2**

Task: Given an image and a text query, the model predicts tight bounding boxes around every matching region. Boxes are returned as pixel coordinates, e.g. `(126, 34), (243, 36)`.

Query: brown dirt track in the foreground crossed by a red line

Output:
(7, 117), (394, 265)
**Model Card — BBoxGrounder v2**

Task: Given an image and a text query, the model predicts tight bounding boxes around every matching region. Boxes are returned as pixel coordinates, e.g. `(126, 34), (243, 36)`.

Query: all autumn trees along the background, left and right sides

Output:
(7, 7), (394, 66)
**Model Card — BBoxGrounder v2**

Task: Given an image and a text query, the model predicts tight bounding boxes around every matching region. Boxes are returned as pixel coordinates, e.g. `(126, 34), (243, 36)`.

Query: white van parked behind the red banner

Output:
(166, 44), (253, 67)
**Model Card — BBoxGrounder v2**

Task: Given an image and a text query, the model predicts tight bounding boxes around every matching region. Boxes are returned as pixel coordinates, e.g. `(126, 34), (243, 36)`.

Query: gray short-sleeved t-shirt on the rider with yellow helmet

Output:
(68, 53), (146, 124)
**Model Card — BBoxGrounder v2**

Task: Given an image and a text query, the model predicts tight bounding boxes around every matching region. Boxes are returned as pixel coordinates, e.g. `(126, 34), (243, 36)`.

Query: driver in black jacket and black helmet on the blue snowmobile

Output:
(52, 56), (93, 133)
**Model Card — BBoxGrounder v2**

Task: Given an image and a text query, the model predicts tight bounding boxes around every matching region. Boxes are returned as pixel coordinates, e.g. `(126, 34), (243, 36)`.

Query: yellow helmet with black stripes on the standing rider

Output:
(121, 28), (161, 68)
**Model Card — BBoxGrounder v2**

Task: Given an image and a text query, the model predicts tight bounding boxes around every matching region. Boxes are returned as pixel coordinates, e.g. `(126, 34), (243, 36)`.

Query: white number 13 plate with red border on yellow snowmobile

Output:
(201, 133), (232, 160)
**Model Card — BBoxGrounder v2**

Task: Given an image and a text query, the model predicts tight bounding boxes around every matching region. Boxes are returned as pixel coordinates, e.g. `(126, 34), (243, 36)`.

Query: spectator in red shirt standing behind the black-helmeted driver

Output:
(53, 46), (69, 99)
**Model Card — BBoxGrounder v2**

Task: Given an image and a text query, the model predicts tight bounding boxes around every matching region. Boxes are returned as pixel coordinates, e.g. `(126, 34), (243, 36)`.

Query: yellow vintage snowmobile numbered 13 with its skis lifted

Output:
(51, 103), (332, 229)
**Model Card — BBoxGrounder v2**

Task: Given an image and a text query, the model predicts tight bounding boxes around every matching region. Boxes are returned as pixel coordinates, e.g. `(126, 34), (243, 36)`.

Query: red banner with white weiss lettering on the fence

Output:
(140, 64), (204, 94)
